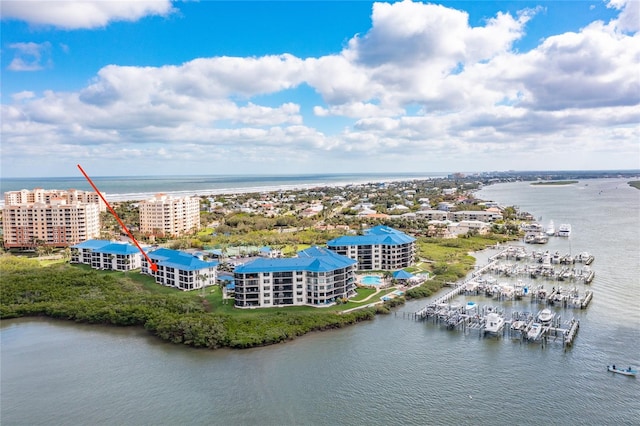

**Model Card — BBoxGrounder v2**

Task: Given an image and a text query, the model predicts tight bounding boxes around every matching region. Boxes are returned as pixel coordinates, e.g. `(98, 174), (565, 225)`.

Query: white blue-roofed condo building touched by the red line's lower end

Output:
(141, 248), (218, 291)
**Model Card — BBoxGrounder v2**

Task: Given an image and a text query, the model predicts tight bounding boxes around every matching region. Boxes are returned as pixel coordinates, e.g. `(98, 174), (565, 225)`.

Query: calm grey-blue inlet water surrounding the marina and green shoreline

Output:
(1, 179), (640, 425)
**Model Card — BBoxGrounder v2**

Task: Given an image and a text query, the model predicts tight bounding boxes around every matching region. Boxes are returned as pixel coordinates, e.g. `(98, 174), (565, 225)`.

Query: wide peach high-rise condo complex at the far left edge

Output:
(2, 197), (100, 249)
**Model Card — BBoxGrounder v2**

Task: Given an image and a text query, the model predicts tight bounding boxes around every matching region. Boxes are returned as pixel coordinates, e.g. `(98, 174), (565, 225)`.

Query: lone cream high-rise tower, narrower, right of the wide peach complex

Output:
(139, 194), (200, 237)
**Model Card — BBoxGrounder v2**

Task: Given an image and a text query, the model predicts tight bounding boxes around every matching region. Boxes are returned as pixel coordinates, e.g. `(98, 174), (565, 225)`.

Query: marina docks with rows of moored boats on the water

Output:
(412, 246), (595, 348)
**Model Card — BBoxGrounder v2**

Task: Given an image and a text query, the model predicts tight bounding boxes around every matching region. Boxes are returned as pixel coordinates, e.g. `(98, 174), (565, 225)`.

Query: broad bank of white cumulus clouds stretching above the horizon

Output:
(0, 0), (640, 172)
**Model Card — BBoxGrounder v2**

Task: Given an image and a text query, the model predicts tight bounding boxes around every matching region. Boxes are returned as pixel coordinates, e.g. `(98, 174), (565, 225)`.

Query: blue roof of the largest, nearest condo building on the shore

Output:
(235, 247), (357, 274)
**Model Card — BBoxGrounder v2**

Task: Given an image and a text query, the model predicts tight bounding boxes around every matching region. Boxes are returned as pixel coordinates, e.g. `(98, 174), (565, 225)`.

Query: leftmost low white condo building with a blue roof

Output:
(71, 240), (142, 271)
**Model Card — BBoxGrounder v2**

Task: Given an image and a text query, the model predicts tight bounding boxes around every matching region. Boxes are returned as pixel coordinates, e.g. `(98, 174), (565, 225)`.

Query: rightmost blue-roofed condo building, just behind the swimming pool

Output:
(327, 225), (416, 271)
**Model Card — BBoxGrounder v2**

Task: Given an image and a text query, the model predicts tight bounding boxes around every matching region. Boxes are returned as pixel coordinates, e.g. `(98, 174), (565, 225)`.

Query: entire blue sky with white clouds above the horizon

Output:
(0, 0), (640, 177)
